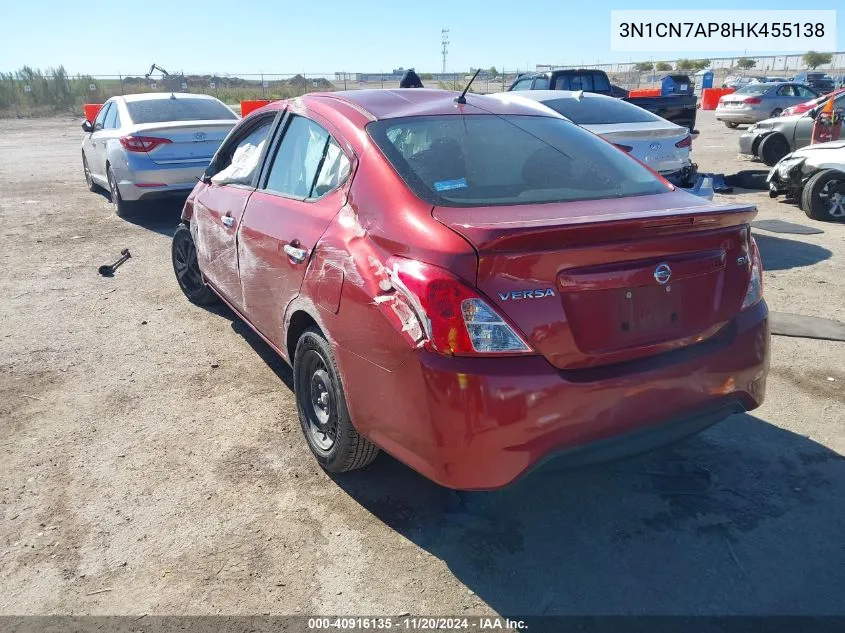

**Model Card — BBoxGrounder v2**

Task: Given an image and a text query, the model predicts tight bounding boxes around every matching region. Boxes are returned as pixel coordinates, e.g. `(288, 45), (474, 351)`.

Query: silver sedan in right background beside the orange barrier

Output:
(716, 82), (819, 127)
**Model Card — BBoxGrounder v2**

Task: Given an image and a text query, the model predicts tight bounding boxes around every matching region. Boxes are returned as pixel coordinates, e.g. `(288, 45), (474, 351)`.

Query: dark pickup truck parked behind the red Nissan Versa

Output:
(508, 69), (698, 132)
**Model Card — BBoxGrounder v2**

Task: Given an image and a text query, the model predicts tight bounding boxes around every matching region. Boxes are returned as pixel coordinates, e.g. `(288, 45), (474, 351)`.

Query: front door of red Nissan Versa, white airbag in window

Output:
(191, 112), (277, 310)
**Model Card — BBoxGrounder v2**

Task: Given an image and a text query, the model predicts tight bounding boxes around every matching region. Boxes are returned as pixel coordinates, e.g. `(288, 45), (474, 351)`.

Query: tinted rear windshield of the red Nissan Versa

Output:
(367, 115), (667, 207)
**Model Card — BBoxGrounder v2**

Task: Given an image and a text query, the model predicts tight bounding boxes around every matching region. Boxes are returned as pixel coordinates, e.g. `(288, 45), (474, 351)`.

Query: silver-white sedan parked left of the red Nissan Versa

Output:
(82, 92), (238, 215)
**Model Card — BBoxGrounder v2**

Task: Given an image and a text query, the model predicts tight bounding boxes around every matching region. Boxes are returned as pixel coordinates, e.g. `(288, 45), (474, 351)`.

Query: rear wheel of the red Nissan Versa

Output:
(293, 328), (378, 473)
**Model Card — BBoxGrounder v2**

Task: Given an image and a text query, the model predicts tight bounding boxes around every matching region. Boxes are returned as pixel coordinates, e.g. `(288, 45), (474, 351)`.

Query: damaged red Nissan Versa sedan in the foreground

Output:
(173, 89), (769, 489)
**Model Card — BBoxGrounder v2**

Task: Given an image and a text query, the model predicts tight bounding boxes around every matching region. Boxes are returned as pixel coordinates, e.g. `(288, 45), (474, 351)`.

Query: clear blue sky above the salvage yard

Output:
(0, 0), (845, 75)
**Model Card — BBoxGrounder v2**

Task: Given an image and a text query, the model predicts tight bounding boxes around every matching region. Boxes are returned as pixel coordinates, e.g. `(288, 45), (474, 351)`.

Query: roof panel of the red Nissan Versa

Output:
(314, 88), (557, 120)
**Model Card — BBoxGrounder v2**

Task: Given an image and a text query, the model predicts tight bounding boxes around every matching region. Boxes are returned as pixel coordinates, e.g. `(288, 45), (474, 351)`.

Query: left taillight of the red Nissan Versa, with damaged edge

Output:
(376, 257), (534, 355)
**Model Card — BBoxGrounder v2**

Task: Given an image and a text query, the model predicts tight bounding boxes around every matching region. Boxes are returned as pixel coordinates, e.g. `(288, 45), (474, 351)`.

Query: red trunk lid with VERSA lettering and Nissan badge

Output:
(433, 192), (756, 369)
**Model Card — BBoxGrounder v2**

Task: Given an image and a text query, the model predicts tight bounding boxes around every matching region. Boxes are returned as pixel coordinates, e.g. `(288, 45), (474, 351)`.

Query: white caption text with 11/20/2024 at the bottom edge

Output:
(308, 616), (528, 631)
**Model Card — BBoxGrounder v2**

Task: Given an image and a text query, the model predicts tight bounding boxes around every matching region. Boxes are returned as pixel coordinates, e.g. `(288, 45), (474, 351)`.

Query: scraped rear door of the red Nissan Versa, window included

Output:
(238, 115), (354, 349)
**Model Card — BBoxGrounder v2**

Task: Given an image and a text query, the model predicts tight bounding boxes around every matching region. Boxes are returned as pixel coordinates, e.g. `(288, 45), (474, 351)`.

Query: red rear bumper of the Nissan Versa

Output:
(337, 302), (769, 489)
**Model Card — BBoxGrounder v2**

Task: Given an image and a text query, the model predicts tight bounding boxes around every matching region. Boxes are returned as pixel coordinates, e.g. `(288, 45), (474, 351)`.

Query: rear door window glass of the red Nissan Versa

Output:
(264, 116), (350, 200)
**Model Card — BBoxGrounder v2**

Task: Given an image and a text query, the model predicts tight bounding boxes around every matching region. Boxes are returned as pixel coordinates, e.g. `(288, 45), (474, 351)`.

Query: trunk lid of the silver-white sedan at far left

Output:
(131, 120), (237, 165)
